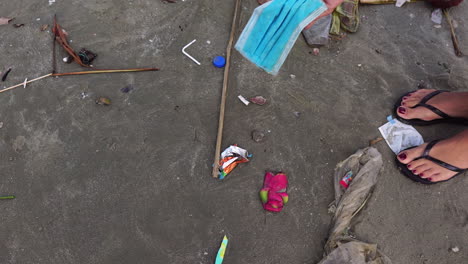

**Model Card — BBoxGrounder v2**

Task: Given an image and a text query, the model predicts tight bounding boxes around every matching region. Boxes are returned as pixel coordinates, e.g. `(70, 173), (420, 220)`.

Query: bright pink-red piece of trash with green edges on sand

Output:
(260, 172), (289, 212)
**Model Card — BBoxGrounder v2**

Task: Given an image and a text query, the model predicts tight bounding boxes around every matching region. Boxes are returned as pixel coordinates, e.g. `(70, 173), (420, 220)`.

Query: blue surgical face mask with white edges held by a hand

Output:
(236, 0), (327, 75)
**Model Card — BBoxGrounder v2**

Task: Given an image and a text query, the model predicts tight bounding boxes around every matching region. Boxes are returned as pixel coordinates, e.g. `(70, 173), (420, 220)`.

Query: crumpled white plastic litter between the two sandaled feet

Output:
(379, 119), (424, 154)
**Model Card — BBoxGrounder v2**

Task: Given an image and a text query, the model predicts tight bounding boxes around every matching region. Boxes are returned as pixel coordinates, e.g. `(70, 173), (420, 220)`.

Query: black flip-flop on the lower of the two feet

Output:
(395, 140), (467, 184)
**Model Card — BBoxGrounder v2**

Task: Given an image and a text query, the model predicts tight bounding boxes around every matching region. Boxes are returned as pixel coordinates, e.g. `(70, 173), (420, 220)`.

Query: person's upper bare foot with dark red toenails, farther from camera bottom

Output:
(396, 89), (468, 121)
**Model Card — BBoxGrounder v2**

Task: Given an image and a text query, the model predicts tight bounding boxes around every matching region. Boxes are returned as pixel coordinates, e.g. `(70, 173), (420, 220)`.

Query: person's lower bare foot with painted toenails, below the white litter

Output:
(398, 129), (468, 182)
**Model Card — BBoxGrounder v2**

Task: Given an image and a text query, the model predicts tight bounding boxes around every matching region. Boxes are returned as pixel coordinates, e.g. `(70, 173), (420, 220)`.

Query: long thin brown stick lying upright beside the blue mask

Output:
(213, 0), (241, 178)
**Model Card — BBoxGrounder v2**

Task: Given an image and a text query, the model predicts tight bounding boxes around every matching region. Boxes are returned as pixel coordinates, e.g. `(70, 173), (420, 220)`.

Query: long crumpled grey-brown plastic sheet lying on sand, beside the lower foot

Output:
(318, 147), (392, 264)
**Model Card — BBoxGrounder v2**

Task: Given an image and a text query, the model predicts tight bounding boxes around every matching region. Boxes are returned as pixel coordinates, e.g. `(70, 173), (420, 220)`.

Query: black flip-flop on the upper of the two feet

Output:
(393, 90), (468, 126)
